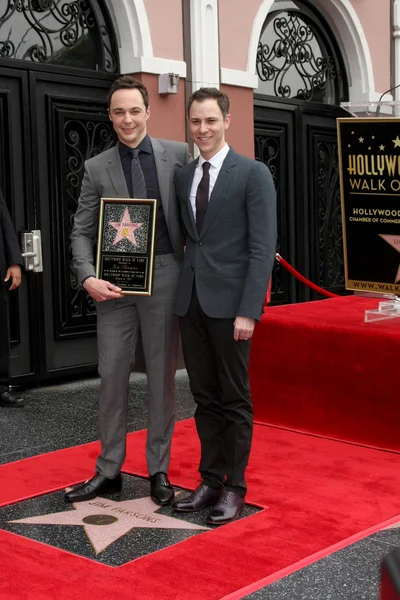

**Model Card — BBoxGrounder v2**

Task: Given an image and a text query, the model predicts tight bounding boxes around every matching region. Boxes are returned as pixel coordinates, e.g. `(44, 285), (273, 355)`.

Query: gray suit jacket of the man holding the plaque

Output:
(71, 138), (190, 282)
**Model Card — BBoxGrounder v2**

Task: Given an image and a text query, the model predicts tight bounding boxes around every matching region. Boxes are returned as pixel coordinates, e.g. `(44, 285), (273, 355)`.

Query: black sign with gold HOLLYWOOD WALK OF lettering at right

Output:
(338, 117), (400, 295)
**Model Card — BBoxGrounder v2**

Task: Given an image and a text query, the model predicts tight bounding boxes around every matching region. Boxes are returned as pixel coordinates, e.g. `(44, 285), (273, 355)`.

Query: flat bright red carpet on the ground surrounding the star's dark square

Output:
(0, 421), (400, 600)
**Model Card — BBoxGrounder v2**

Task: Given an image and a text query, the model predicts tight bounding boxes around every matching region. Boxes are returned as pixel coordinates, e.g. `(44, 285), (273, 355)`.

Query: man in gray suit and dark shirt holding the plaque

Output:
(66, 76), (190, 504)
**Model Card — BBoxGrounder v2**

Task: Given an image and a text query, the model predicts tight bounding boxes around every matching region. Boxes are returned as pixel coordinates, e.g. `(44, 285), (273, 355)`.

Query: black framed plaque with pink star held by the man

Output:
(96, 198), (157, 296)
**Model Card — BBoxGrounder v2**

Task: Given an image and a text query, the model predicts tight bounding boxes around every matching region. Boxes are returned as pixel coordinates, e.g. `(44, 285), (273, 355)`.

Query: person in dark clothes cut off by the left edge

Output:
(0, 190), (24, 408)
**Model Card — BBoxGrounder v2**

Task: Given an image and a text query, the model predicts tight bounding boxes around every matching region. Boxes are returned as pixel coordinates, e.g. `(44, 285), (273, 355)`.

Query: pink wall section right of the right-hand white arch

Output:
(351, 0), (392, 93)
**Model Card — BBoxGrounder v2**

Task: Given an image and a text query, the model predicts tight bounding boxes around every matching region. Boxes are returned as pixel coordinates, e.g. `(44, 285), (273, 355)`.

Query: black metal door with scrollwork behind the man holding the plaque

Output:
(0, 68), (113, 383)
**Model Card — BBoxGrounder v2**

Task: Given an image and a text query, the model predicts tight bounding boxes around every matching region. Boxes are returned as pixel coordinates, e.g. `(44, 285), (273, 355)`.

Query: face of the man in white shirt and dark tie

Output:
(189, 98), (231, 160)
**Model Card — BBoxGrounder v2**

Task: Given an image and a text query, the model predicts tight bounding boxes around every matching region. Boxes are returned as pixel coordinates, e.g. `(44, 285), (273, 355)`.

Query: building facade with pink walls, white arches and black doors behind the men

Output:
(0, 0), (394, 383)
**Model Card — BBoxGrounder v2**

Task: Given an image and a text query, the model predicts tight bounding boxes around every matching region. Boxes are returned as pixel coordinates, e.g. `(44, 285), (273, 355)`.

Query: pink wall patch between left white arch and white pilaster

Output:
(144, 0), (183, 60)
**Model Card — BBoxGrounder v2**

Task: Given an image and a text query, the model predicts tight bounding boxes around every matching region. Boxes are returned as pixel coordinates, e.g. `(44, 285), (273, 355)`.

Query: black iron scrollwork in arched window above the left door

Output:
(0, 0), (118, 73)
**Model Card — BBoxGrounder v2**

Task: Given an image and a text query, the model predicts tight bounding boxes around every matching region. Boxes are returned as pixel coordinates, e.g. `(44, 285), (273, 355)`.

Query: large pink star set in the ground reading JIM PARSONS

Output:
(9, 490), (209, 555)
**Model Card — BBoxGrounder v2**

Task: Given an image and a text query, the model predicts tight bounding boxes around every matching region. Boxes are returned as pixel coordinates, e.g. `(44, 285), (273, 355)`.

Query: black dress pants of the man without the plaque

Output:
(180, 288), (253, 496)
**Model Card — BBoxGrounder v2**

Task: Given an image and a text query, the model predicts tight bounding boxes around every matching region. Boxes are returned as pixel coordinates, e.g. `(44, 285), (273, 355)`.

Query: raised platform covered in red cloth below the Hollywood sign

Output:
(250, 296), (400, 451)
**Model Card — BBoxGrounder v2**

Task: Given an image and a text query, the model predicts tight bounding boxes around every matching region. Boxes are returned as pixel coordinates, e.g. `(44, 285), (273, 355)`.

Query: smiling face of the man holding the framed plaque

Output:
(108, 89), (150, 148)
